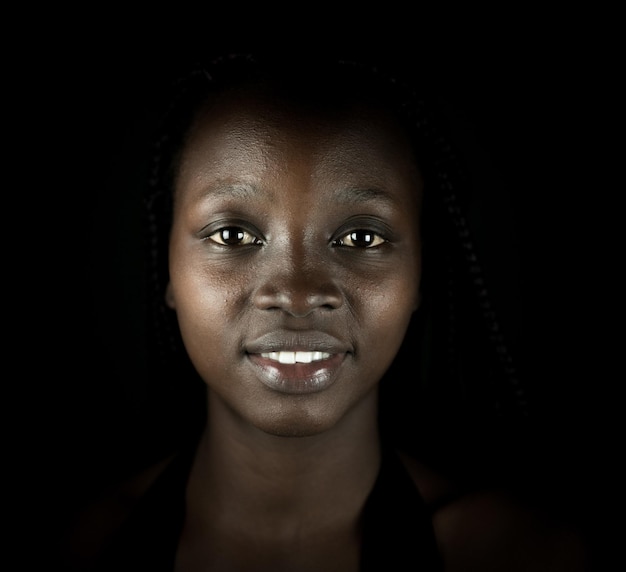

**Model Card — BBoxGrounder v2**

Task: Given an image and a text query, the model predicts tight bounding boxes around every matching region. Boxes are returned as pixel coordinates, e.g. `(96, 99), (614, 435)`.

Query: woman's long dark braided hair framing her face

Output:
(144, 54), (528, 464)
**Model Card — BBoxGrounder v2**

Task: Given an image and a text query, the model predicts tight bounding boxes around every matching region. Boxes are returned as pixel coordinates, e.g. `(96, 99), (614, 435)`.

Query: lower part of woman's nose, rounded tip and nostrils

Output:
(253, 249), (343, 317)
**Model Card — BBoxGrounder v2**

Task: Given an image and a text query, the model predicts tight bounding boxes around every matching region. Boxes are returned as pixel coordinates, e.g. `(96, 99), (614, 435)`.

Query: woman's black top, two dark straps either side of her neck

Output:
(97, 444), (443, 572)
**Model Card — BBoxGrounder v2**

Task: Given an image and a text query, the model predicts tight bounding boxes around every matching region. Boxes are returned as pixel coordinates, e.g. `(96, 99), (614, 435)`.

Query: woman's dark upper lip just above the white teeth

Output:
(245, 330), (351, 354)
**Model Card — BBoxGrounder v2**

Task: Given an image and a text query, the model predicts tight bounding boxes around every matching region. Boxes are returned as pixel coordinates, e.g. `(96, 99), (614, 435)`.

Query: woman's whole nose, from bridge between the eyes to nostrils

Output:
(254, 231), (342, 316)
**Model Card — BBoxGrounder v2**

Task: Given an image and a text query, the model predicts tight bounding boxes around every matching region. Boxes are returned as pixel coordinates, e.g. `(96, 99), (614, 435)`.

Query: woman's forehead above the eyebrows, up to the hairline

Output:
(179, 87), (417, 190)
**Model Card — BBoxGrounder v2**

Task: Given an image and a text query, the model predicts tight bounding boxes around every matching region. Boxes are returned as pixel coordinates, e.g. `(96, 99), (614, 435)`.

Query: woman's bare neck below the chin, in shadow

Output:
(188, 388), (380, 527)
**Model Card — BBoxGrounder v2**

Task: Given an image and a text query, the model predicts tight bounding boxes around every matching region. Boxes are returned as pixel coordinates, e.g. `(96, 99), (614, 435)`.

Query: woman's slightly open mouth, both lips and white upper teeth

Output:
(246, 332), (351, 395)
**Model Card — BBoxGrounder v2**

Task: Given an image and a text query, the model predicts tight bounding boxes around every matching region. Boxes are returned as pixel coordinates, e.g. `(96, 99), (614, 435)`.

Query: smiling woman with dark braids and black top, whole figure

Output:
(57, 52), (584, 572)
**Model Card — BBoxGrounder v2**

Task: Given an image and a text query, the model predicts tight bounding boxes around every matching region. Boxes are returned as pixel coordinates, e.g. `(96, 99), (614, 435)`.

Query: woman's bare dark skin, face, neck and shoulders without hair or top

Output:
(59, 89), (584, 572)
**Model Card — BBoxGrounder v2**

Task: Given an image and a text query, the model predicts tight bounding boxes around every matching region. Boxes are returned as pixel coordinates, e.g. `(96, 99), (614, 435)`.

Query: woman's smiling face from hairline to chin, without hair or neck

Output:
(167, 91), (422, 435)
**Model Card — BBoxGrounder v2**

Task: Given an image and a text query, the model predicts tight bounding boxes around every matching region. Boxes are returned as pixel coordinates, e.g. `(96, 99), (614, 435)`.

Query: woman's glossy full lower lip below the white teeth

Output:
(248, 354), (346, 395)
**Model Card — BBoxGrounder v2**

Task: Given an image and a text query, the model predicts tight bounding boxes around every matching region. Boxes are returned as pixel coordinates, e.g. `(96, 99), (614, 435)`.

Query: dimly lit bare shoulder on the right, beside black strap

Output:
(404, 452), (590, 572)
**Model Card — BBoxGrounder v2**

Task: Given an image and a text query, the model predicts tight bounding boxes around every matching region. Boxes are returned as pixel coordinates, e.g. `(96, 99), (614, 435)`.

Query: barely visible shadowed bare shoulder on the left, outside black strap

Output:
(58, 457), (172, 571)
